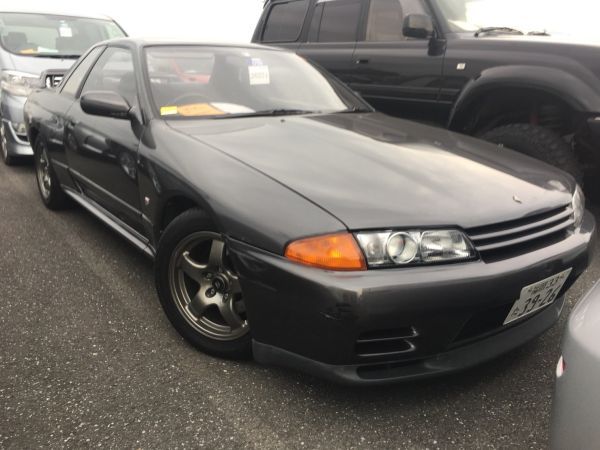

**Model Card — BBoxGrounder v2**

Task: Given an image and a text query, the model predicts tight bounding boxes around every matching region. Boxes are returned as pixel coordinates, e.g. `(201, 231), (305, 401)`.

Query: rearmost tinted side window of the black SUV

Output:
(263, 0), (308, 42)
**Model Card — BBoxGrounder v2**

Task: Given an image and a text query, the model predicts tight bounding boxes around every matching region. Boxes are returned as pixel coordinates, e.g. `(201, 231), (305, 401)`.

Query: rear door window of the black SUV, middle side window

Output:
(308, 0), (361, 42)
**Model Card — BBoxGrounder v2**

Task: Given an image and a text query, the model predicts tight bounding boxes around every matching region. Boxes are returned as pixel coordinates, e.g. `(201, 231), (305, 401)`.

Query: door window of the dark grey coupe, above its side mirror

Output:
(81, 47), (137, 106)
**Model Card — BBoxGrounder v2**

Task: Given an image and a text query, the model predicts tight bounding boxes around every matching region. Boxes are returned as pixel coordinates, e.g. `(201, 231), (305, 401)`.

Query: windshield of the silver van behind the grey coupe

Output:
(0, 13), (125, 57)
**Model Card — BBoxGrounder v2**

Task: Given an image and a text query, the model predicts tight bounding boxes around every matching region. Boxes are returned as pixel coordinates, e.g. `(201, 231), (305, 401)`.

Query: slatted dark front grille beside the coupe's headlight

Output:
(467, 206), (574, 260)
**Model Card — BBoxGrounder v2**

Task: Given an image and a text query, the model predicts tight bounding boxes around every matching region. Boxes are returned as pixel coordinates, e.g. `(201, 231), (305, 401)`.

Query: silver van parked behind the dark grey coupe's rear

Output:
(0, 9), (125, 164)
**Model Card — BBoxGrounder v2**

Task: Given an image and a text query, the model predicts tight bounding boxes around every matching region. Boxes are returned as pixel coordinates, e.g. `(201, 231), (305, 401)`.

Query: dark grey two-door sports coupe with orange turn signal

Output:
(25, 39), (595, 384)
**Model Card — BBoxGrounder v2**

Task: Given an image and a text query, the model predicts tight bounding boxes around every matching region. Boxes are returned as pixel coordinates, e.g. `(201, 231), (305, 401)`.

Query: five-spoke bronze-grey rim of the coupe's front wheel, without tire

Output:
(169, 232), (249, 341)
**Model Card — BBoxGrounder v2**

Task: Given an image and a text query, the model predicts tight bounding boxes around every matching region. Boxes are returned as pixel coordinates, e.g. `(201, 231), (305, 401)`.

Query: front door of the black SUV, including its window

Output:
(348, 0), (444, 123)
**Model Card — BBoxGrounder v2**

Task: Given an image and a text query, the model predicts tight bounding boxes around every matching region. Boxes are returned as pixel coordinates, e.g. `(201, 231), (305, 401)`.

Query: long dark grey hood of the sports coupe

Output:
(170, 113), (574, 230)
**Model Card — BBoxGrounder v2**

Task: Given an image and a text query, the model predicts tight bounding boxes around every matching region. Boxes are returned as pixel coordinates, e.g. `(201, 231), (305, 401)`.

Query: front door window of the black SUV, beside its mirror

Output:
(365, 0), (427, 42)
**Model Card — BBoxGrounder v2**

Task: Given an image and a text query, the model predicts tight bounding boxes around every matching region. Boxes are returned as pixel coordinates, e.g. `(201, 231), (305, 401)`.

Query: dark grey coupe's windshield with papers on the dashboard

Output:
(146, 46), (365, 119)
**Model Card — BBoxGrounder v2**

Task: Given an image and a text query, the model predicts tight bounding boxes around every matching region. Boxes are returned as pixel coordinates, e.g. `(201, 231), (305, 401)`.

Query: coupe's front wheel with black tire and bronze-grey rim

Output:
(155, 209), (252, 359)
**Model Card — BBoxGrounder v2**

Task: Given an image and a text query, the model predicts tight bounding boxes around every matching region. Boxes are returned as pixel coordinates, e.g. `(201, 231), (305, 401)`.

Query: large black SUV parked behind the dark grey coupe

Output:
(253, 0), (600, 181)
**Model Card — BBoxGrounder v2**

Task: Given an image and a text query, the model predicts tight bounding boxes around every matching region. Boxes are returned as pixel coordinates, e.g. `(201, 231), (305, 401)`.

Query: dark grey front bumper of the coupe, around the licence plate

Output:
(230, 213), (595, 384)
